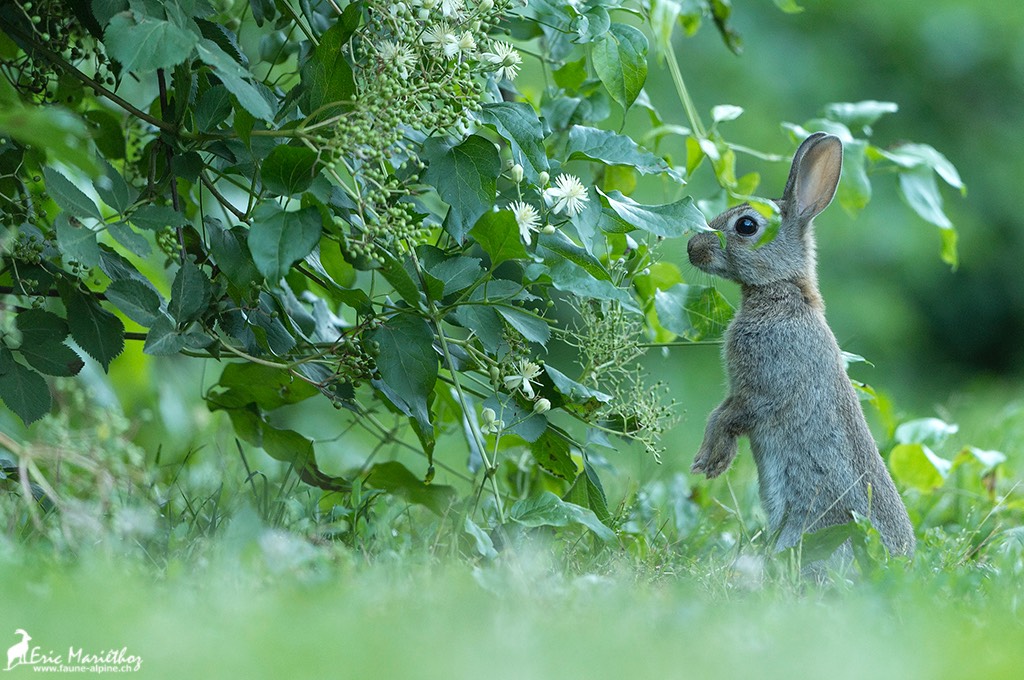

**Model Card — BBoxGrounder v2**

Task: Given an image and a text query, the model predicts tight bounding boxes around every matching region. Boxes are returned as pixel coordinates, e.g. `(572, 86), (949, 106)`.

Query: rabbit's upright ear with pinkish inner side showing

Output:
(782, 132), (843, 221)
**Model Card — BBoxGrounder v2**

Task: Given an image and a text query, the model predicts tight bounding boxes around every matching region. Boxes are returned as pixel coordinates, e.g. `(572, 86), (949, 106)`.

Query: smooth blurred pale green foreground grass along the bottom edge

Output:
(0, 540), (1024, 680)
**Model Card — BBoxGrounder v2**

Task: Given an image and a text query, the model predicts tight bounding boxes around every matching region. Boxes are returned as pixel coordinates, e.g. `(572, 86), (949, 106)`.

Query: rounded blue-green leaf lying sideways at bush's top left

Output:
(103, 11), (199, 73)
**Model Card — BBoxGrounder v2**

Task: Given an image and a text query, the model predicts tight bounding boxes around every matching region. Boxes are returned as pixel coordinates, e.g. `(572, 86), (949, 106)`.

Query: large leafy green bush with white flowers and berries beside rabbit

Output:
(0, 0), (963, 540)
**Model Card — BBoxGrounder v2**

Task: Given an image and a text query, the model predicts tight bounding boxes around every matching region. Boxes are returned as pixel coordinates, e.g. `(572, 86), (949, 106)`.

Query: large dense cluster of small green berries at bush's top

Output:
(316, 0), (522, 258)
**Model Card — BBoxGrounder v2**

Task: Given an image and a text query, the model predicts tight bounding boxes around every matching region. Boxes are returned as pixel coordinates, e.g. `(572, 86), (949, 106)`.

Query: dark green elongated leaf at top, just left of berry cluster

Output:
(301, 4), (360, 118)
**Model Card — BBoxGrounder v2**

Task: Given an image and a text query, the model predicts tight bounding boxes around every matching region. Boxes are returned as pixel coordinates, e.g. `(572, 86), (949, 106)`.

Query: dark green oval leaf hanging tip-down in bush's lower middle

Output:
(371, 314), (437, 429)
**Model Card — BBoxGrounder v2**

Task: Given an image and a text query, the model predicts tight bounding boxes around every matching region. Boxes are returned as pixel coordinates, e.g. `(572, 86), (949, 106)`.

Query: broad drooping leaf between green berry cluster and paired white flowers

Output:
(423, 134), (502, 244)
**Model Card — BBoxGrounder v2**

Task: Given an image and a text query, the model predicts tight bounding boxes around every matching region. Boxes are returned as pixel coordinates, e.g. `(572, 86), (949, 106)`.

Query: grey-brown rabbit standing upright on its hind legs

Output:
(687, 132), (915, 557)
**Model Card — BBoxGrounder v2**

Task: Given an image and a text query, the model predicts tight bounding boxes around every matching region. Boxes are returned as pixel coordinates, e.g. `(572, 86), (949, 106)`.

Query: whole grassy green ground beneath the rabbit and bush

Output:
(0, 378), (1024, 680)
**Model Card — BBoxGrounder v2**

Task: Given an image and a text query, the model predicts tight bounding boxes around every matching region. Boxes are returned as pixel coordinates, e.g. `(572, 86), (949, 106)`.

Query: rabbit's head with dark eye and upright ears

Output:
(686, 132), (843, 286)
